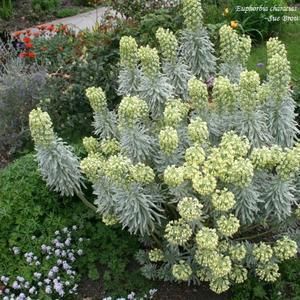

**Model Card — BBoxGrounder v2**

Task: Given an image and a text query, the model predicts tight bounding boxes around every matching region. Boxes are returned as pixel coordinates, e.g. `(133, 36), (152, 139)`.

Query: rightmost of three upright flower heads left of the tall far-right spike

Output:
(239, 71), (260, 112)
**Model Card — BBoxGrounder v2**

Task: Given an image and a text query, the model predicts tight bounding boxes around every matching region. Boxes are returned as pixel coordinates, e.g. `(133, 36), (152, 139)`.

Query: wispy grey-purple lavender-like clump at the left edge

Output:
(0, 48), (46, 155)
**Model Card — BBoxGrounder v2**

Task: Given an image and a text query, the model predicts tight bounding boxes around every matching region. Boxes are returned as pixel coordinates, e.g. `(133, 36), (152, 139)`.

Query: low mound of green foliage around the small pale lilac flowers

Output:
(0, 154), (151, 299)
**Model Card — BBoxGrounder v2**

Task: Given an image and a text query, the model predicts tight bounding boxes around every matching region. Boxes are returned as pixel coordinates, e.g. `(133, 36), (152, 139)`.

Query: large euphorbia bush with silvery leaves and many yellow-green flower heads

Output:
(30, 0), (300, 293)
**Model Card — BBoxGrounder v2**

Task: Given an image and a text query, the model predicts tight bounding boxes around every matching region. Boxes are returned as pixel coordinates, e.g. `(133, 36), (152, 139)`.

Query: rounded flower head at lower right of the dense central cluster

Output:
(226, 158), (254, 187)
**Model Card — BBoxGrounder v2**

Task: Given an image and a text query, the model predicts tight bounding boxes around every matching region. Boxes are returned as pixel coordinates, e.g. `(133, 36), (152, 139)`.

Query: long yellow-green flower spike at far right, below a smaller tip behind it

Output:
(267, 54), (291, 101)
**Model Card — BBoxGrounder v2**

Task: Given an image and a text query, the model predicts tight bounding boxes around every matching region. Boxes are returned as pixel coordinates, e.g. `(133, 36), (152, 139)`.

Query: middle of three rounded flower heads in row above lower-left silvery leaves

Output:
(104, 154), (132, 182)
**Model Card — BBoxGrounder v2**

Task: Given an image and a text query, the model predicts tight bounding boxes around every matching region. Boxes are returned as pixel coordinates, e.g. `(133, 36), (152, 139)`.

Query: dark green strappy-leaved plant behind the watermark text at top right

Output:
(229, 0), (286, 41)
